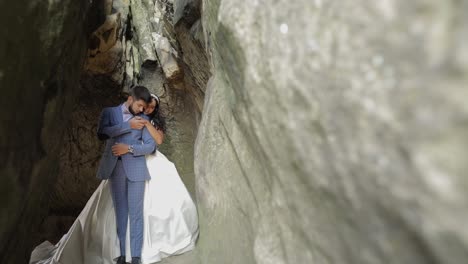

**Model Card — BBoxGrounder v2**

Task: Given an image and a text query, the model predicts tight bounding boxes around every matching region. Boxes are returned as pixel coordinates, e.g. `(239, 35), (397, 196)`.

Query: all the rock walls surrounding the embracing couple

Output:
(0, 0), (468, 264)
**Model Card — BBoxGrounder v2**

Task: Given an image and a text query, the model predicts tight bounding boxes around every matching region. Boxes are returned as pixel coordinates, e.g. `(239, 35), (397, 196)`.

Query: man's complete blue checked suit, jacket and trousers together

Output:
(97, 105), (156, 257)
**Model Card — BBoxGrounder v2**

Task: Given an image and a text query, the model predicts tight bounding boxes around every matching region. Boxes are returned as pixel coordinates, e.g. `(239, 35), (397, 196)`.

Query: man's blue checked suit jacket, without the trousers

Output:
(97, 105), (157, 181)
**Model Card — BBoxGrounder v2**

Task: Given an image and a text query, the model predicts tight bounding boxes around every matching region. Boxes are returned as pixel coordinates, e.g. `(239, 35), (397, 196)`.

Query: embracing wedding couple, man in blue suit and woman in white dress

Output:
(30, 86), (198, 264)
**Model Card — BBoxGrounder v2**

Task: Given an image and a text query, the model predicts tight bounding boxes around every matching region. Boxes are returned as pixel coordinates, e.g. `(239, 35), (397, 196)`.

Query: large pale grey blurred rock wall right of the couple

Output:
(195, 0), (468, 264)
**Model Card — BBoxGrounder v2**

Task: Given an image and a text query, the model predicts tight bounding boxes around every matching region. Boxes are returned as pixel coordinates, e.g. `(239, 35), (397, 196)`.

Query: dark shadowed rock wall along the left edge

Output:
(0, 0), (103, 263)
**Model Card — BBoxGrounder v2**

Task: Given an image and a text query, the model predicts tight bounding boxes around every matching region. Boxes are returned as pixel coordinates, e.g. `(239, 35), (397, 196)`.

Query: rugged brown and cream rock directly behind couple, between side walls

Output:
(44, 1), (209, 248)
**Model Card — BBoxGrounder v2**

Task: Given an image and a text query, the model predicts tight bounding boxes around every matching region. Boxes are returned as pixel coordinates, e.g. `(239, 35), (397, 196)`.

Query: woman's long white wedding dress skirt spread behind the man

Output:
(29, 151), (198, 264)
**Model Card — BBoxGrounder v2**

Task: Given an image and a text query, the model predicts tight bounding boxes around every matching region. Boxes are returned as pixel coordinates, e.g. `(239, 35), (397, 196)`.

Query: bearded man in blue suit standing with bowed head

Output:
(97, 86), (156, 264)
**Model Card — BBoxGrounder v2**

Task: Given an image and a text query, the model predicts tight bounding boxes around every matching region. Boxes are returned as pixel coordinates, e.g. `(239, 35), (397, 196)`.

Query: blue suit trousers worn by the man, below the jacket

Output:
(110, 159), (145, 257)
